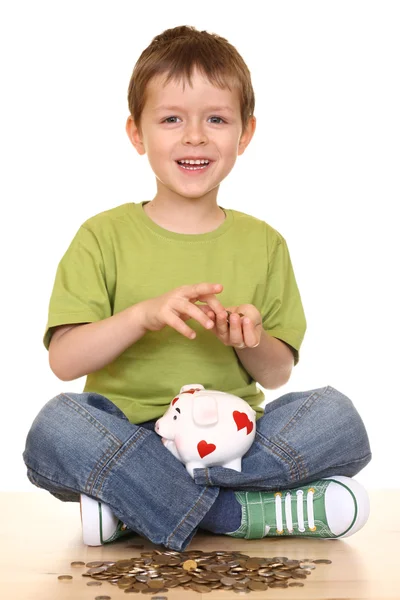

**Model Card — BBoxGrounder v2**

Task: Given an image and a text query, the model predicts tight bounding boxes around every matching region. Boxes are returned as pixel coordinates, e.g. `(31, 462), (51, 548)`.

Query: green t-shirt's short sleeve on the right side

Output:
(261, 234), (307, 365)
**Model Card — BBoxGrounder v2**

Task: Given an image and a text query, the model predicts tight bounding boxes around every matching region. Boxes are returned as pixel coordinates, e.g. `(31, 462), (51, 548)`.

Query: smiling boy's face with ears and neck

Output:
(126, 70), (256, 204)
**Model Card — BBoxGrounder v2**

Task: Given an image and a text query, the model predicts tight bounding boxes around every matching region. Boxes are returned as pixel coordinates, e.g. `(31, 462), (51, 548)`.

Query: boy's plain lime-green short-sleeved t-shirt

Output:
(43, 201), (306, 423)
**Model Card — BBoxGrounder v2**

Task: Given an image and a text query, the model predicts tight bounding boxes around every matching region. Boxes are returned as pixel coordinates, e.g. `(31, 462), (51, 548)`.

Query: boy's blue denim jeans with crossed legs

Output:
(23, 386), (371, 550)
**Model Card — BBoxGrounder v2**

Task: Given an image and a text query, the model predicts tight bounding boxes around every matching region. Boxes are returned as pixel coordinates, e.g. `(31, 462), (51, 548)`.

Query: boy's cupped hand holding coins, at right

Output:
(199, 304), (262, 350)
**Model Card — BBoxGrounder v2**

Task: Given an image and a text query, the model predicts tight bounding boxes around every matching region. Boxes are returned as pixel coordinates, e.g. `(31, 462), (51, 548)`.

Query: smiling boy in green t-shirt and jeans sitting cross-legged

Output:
(23, 26), (371, 550)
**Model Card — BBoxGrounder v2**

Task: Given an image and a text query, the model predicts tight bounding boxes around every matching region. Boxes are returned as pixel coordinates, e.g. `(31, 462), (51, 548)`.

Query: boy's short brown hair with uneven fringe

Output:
(128, 25), (255, 133)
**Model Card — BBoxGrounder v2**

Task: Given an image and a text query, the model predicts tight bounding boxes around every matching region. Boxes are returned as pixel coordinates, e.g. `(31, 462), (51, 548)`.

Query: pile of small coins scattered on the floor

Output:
(60, 550), (332, 598)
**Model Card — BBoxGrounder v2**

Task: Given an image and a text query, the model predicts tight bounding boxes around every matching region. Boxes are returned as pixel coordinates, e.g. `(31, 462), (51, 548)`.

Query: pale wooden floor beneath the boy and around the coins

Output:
(0, 490), (400, 600)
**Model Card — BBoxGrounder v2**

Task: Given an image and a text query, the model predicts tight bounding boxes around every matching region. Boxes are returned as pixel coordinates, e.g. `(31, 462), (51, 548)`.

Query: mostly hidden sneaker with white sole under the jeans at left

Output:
(80, 494), (134, 546)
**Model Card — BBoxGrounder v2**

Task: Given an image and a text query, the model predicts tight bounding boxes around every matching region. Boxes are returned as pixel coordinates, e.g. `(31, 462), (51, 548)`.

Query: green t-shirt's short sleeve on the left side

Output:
(43, 226), (111, 350)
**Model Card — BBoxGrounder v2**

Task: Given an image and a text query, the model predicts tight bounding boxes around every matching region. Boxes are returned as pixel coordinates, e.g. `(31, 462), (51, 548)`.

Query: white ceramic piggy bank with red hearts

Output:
(154, 383), (256, 477)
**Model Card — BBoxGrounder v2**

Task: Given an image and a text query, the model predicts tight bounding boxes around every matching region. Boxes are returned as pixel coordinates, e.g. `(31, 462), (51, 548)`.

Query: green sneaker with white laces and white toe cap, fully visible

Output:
(226, 476), (369, 539)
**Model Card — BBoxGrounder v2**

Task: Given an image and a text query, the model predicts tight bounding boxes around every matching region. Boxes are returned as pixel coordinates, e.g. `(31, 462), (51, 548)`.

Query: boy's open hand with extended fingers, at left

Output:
(140, 283), (224, 339)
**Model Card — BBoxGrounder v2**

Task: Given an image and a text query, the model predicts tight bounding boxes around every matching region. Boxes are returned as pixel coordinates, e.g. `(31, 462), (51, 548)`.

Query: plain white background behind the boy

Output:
(0, 0), (400, 491)
